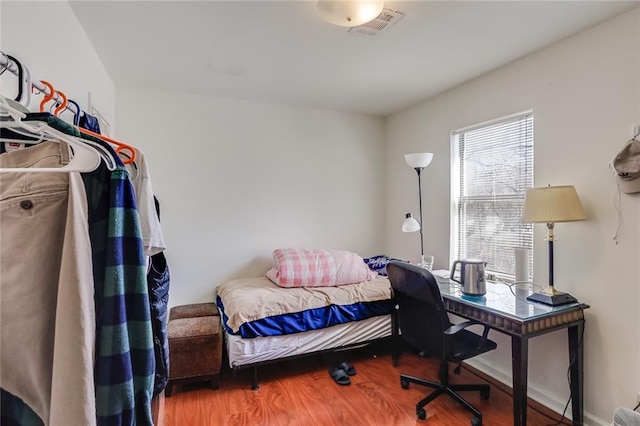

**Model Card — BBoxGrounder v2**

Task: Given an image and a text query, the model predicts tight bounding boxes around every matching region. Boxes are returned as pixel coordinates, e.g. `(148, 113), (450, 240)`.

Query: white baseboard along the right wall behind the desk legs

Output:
(464, 358), (613, 426)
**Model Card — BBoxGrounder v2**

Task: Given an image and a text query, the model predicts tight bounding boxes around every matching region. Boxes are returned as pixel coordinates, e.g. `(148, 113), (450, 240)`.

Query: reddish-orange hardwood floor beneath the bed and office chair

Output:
(159, 347), (572, 426)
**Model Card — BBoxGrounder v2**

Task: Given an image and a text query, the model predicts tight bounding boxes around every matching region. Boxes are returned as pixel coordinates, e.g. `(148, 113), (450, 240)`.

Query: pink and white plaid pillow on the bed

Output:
(267, 248), (377, 287)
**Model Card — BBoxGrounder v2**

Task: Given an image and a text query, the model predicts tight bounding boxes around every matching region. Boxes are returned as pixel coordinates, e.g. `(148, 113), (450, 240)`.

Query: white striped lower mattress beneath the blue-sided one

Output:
(225, 315), (391, 369)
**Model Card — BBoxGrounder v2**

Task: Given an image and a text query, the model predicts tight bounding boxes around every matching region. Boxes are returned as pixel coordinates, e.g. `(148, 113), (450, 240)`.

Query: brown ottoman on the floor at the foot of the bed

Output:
(165, 308), (222, 396)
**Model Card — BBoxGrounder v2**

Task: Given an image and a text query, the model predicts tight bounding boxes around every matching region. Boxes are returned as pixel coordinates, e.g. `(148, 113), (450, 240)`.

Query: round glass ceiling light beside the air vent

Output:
(318, 0), (384, 27)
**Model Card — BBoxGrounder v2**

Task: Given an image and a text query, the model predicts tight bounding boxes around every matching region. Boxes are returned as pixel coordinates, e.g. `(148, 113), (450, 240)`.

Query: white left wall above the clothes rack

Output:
(0, 0), (115, 126)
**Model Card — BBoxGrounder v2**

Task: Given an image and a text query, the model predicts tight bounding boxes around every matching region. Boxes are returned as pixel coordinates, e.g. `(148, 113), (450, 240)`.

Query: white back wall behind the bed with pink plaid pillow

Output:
(116, 89), (384, 306)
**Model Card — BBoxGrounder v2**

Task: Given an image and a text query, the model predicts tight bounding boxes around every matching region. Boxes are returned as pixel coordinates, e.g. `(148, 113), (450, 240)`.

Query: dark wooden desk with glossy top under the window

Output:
(396, 277), (589, 426)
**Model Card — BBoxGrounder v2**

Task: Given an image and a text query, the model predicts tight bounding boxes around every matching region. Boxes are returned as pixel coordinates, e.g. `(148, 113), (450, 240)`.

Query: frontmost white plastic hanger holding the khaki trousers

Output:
(0, 96), (101, 173)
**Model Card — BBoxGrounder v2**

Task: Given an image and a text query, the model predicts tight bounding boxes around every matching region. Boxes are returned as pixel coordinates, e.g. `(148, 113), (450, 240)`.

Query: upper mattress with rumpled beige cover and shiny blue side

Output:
(216, 277), (393, 338)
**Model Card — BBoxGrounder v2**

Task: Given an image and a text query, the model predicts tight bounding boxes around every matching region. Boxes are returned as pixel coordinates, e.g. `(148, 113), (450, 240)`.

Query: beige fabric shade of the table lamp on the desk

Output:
(522, 185), (587, 223)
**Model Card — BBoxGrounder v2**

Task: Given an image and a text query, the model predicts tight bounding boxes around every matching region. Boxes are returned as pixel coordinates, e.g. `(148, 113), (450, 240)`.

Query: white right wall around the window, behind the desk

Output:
(385, 9), (640, 424)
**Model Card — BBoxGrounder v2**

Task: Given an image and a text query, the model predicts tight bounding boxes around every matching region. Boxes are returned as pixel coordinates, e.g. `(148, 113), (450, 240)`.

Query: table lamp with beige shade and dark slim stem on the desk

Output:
(522, 185), (587, 306)
